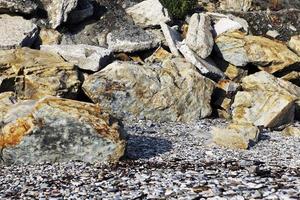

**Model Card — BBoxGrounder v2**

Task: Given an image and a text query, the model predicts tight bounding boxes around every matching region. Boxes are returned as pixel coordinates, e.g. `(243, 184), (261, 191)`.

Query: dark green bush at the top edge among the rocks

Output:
(160, 0), (198, 19)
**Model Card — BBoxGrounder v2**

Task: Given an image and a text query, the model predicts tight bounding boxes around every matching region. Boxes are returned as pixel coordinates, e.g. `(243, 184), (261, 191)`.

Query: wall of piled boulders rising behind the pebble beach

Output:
(0, 0), (300, 163)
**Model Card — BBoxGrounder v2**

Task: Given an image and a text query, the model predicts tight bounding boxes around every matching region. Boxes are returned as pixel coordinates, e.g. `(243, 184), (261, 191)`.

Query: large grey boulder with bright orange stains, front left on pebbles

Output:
(0, 97), (125, 164)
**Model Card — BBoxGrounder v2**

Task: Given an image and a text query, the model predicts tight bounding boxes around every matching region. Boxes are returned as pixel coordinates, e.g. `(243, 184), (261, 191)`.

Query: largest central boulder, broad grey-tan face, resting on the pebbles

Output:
(83, 58), (214, 122)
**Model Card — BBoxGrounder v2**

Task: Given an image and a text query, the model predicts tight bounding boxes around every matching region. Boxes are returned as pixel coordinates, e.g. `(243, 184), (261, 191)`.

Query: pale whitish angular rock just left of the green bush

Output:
(126, 0), (171, 28)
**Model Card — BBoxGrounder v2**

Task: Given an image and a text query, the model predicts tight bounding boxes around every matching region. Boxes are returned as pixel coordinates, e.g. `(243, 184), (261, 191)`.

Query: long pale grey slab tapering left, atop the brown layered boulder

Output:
(41, 44), (111, 72)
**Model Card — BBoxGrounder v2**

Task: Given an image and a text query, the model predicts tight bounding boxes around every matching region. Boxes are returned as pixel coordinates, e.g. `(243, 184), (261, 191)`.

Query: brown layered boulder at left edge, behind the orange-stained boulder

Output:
(0, 48), (80, 99)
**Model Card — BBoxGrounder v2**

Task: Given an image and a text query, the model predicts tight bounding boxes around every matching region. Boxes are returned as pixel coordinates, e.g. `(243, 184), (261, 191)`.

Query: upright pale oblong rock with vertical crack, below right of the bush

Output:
(185, 13), (214, 59)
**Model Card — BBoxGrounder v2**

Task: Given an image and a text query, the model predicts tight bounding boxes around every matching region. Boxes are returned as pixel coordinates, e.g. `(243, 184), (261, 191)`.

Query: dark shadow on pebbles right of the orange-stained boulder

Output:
(124, 135), (172, 160)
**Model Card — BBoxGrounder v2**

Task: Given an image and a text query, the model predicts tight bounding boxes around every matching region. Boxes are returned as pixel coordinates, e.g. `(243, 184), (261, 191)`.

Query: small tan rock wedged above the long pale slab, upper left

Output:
(40, 28), (62, 45)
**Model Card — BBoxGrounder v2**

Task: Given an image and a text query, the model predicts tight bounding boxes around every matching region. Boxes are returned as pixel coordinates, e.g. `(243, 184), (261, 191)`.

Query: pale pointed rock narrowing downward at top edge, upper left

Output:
(40, 0), (78, 29)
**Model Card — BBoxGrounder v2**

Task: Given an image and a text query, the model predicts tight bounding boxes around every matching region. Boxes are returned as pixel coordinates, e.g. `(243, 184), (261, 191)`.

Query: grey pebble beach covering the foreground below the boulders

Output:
(0, 119), (300, 199)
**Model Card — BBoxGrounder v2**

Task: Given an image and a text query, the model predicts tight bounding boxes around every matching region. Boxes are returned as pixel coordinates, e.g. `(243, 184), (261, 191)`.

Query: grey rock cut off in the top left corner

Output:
(0, 0), (37, 14)
